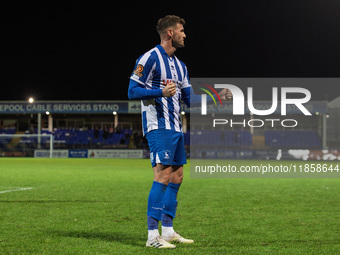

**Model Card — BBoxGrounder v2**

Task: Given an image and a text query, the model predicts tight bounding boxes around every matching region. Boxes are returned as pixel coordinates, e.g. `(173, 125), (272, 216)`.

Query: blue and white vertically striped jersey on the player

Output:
(129, 45), (190, 135)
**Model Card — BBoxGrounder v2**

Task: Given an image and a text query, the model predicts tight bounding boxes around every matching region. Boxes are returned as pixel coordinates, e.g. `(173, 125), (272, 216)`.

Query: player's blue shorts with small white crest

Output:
(146, 129), (187, 167)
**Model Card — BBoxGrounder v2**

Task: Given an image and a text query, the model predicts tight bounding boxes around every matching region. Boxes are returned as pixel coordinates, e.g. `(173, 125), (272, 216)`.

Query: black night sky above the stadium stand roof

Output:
(0, 0), (340, 101)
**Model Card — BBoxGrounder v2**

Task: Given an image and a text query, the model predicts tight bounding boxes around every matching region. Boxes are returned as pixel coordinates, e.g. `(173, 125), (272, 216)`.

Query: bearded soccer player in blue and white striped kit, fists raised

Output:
(128, 15), (228, 248)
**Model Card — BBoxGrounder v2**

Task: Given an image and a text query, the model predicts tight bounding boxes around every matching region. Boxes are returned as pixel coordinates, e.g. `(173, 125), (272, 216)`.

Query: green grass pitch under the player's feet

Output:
(0, 158), (340, 255)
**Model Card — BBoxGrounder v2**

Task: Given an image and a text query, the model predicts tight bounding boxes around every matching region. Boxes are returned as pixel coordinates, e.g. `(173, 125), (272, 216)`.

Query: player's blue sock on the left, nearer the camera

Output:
(147, 181), (167, 223)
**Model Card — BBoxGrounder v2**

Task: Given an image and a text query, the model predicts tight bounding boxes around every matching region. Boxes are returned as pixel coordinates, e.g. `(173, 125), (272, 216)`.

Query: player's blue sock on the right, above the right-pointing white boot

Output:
(162, 182), (181, 220)
